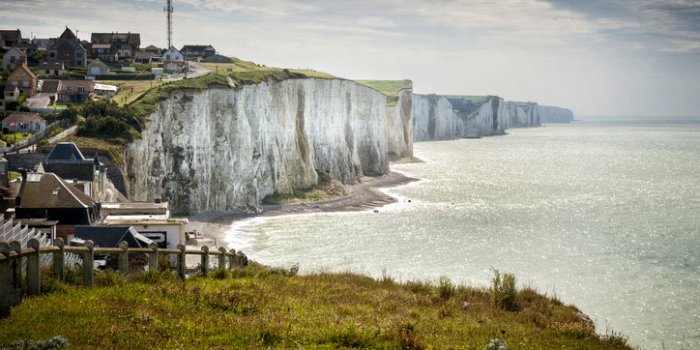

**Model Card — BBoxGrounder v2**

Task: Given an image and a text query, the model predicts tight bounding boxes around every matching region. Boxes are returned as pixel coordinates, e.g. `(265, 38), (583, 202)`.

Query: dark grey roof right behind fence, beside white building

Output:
(75, 226), (153, 248)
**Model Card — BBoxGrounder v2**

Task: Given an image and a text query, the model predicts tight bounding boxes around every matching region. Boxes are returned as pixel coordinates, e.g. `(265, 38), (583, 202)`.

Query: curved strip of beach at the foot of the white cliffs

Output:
(186, 171), (419, 249)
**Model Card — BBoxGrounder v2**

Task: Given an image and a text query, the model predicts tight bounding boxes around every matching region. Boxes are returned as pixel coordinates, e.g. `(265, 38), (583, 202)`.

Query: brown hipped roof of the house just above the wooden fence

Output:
(19, 173), (95, 209)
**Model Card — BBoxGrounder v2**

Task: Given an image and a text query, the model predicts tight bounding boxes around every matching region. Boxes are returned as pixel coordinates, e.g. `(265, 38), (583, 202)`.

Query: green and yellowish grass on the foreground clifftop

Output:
(0, 267), (630, 349)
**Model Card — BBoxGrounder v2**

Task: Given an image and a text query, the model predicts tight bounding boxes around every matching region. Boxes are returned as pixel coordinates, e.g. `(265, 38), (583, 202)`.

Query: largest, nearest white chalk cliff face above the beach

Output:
(125, 79), (404, 213)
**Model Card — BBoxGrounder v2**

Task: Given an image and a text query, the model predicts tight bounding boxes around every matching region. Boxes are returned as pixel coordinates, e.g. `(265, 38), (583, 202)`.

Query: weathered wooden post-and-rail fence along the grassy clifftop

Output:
(0, 238), (248, 318)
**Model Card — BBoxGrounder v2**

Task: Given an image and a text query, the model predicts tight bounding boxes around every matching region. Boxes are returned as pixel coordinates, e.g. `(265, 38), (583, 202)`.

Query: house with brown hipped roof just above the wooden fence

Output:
(15, 173), (99, 241)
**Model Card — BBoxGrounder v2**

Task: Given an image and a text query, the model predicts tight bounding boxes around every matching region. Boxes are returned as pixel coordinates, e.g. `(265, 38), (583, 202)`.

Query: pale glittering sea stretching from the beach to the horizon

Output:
(229, 119), (700, 349)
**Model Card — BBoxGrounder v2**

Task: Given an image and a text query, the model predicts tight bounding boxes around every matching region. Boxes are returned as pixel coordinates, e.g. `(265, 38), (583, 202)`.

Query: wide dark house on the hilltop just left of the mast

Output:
(90, 32), (141, 62)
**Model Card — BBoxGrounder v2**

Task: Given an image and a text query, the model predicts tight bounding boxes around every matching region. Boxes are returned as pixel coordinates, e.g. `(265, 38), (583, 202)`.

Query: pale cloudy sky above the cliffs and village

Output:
(0, 0), (700, 116)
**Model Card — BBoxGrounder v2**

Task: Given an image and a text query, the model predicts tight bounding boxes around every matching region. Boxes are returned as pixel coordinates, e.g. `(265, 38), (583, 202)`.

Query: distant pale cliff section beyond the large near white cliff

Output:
(413, 94), (540, 142)
